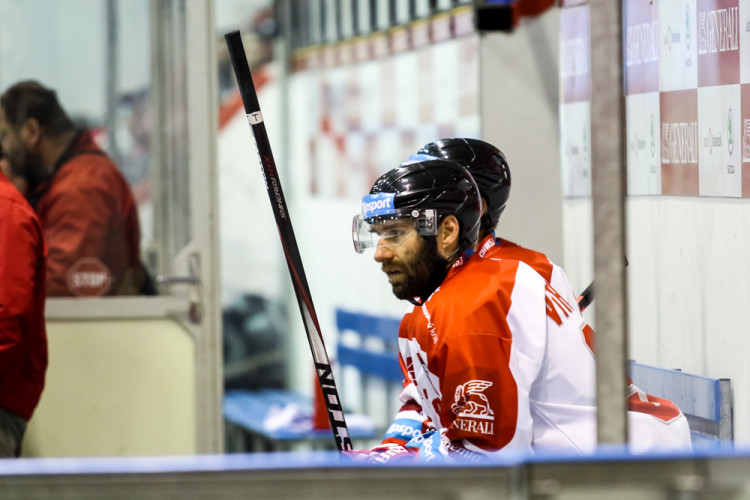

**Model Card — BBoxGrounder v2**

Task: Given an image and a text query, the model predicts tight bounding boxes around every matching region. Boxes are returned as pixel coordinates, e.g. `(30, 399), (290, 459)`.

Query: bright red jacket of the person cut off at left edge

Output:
(0, 173), (47, 420)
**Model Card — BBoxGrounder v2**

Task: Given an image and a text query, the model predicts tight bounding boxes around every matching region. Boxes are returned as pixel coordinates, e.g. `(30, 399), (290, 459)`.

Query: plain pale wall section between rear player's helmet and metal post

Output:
(480, 9), (564, 265)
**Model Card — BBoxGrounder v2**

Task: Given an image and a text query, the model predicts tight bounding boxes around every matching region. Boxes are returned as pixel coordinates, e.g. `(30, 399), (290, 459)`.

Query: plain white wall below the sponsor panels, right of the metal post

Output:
(627, 196), (750, 441)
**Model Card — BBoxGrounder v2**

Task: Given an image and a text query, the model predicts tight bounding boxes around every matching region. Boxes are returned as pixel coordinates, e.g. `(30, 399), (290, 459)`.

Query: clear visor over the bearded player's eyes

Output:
(352, 209), (437, 253)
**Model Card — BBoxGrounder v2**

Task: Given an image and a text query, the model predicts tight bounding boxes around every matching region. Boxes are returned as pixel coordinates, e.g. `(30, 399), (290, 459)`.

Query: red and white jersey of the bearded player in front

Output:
(399, 243), (596, 460)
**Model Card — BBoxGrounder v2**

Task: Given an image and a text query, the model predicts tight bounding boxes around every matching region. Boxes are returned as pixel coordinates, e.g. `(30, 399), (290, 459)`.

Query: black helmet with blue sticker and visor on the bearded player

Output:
(352, 159), (481, 258)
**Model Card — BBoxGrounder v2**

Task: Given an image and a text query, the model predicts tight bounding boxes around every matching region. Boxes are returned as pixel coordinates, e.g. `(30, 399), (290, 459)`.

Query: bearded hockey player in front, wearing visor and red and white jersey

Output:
(354, 160), (596, 461)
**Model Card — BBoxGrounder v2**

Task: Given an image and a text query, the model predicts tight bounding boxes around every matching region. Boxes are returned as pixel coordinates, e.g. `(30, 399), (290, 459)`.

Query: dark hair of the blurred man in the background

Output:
(0, 80), (75, 135)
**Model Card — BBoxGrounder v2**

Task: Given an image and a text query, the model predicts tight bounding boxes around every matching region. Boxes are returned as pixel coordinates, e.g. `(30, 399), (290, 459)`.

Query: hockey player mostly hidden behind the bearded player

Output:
(378, 138), (691, 453)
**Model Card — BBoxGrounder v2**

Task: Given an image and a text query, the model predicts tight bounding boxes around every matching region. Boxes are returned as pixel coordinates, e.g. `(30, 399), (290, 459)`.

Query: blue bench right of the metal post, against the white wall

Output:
(630, 361), (734, 446)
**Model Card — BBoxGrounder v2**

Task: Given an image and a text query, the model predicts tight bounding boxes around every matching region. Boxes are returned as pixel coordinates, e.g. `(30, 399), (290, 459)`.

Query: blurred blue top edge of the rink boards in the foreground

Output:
(0, 446), (750, 477)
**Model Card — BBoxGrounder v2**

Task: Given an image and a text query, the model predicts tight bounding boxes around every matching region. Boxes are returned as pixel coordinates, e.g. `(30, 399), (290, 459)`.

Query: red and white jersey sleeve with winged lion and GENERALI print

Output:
(432, 263), (547, 456)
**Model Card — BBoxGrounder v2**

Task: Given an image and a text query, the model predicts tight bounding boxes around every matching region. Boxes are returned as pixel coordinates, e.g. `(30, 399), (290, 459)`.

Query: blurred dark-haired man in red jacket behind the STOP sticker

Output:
(0, 80), (150, 297)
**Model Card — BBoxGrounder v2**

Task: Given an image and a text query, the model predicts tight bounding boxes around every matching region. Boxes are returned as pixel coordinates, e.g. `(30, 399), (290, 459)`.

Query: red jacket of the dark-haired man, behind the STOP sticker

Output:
(30, 132), (142, 297)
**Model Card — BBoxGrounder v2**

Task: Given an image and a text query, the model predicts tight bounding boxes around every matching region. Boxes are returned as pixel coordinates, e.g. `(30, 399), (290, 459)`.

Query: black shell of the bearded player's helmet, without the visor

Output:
(370, 159), (481, 260)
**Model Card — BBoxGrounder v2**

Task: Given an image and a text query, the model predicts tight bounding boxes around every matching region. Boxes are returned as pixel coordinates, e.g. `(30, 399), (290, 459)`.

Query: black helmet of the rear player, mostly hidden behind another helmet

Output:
(416, 138), (510, 229)
